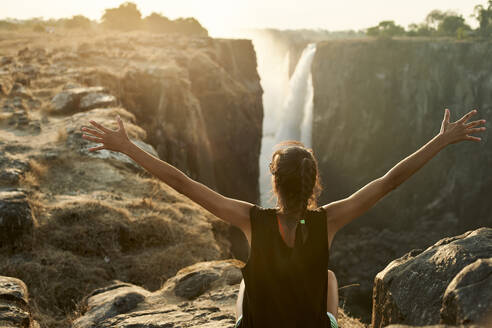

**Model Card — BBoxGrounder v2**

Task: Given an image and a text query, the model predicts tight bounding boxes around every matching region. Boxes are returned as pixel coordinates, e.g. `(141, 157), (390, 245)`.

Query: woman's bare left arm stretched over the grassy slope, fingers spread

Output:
(82, 115), (253, 233)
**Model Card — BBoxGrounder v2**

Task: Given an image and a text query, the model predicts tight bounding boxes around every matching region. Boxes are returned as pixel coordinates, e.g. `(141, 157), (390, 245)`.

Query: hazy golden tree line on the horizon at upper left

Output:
(0, 2), (208, 36)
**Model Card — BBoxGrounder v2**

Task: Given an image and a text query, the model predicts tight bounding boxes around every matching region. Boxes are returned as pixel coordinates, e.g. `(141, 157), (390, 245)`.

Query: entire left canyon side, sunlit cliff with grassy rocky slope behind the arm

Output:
(0, 32), (263, 327)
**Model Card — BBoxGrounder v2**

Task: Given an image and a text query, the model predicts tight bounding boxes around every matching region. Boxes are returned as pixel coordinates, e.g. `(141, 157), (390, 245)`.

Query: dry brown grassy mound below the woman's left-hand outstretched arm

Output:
(0, 195), (223, 327)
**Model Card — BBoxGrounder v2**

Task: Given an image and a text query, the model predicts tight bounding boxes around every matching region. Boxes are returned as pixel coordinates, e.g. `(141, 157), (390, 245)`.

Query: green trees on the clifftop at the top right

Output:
(366, 0), (492, 40)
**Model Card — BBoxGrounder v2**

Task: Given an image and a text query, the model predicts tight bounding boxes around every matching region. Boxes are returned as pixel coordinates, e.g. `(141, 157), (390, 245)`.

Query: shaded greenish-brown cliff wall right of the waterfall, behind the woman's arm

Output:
(312, 39), (492, 320)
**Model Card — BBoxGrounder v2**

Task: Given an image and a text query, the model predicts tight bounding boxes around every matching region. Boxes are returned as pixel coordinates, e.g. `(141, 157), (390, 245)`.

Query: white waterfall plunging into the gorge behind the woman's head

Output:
(253, 40), (316, 207)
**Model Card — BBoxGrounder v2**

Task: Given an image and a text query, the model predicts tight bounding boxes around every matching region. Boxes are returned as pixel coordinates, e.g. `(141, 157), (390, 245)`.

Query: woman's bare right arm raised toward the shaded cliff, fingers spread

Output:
(323, 109), (485, 239)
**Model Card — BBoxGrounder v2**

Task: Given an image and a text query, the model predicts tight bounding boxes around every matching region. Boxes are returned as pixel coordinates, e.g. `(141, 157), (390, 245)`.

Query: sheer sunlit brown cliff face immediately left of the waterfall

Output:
(74, 36), (263, 260)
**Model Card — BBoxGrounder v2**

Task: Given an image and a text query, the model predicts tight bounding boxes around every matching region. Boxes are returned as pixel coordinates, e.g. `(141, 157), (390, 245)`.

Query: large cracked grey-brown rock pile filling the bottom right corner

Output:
(372, 228), (492, 327)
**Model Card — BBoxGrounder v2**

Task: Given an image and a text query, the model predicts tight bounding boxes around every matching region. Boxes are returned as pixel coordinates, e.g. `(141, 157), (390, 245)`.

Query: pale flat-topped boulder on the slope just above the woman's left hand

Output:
(51, 87), (116, 114)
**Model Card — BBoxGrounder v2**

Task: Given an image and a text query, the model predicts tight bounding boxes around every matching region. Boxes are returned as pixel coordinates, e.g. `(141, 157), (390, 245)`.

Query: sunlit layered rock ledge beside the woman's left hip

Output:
(74, 260), (243, 328)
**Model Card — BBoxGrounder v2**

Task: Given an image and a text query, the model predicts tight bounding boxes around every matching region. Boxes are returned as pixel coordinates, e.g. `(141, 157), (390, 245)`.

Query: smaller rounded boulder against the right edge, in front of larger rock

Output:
(441, 253), (492, 325)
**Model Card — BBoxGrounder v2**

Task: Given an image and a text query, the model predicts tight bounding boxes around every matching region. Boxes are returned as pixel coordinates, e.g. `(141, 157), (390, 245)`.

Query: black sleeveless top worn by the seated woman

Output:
(239, 205), (330, 328)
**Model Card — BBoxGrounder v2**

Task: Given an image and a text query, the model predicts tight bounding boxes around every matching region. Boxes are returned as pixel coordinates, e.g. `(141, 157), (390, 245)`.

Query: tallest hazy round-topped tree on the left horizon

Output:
(102, 2), (142, 31)
